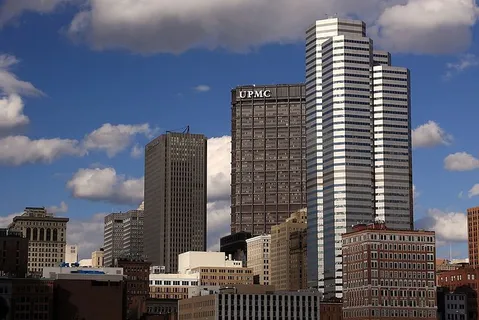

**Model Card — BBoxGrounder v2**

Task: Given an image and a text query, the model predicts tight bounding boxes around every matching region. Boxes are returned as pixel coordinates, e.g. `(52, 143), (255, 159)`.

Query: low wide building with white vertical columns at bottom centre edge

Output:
(178, 286), (321, 320)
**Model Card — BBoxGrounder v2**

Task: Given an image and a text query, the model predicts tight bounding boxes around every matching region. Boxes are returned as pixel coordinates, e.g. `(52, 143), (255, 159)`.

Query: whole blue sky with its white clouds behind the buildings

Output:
(0, 0), (479, 258)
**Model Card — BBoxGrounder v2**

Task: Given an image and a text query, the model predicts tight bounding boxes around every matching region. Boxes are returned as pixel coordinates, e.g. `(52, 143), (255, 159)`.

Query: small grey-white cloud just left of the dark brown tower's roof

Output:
(83, 123), (153, 157)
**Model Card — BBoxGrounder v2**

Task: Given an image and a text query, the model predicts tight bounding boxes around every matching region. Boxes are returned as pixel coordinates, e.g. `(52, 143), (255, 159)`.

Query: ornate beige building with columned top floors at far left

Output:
(9, 207), (69, 275)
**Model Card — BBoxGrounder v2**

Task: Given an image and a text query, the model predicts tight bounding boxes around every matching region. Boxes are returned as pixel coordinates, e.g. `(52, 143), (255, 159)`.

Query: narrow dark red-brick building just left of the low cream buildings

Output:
(117, 259), (151, 320)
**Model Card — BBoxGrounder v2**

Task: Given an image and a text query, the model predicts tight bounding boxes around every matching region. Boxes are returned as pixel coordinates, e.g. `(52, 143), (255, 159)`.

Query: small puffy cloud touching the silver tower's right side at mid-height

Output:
(412, 121), (452, 148)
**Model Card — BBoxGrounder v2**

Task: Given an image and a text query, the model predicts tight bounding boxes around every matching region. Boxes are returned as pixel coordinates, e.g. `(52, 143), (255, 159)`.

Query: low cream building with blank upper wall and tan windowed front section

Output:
(178, 251), (253, 287)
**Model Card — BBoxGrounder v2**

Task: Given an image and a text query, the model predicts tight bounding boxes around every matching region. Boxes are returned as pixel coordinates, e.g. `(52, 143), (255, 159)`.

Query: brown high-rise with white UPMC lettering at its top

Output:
(231, 84), (306, 236)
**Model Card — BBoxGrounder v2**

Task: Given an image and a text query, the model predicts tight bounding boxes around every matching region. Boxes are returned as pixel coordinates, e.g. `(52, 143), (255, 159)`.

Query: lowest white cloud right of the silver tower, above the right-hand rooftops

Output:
(415, 209), (467, 242)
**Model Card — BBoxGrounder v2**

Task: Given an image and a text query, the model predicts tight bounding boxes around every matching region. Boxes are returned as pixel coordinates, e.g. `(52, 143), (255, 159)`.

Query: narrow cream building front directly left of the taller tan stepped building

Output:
(246, 234), (271, 285)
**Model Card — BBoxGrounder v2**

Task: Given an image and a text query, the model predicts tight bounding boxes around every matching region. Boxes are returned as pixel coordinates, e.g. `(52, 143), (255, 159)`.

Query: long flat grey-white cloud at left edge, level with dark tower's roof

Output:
(0, 136), (85, 166)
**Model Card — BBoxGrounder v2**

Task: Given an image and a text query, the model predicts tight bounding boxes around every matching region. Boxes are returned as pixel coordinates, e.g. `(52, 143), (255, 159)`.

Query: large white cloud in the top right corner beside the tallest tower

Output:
(375, 0), (479, 54)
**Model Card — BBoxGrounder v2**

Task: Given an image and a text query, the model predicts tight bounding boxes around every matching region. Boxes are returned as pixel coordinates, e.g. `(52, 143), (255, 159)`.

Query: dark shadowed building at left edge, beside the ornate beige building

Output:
(0, 229), (28, 278)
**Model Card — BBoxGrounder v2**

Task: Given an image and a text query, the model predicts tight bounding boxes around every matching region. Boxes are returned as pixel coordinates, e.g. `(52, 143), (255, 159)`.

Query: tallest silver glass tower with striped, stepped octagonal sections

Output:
(306, 18), (413, 298)
